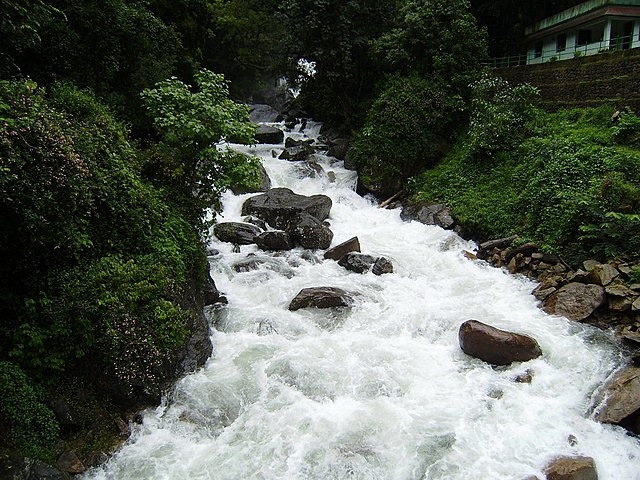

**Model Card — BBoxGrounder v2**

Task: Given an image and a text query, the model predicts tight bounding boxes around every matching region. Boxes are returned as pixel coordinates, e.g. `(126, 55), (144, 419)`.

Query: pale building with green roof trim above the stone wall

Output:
(526, 0), (640, 64)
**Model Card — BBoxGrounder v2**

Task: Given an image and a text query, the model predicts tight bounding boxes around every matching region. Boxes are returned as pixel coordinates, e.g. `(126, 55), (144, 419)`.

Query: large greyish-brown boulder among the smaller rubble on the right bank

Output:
(543, 282), (605, 321)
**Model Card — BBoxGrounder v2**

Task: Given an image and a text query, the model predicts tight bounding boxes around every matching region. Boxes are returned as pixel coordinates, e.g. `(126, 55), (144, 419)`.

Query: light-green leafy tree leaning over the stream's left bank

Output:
(142, 69), (257, 224)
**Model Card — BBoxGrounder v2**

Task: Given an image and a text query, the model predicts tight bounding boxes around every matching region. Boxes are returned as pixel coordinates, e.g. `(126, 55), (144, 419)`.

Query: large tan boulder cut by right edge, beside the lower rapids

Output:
(596, 367), (640, 423)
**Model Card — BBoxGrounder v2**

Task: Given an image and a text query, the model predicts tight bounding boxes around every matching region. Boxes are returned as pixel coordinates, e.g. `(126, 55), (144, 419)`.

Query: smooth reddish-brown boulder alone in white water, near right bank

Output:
(458, 320), (542, 365)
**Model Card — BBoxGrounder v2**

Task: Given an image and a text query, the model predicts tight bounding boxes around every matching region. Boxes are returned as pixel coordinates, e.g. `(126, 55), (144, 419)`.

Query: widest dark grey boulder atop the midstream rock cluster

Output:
(242, 188), (332, 230)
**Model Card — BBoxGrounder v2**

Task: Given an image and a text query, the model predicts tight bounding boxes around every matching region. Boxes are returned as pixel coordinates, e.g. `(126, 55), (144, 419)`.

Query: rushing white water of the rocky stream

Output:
(87, 121), (640, 480)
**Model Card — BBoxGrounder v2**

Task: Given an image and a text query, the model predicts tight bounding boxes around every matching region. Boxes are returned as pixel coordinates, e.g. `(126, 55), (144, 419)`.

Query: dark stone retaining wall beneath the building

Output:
(495, 48), (640, 113)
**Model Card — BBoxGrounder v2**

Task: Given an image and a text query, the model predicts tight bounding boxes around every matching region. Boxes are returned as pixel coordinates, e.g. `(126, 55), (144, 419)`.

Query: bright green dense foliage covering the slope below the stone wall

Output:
(413, 97), (640, 263)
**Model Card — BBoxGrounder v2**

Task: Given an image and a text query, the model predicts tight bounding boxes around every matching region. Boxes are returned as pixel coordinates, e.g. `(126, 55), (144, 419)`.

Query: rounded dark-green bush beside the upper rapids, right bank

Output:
(348, 75), (462, 194)
